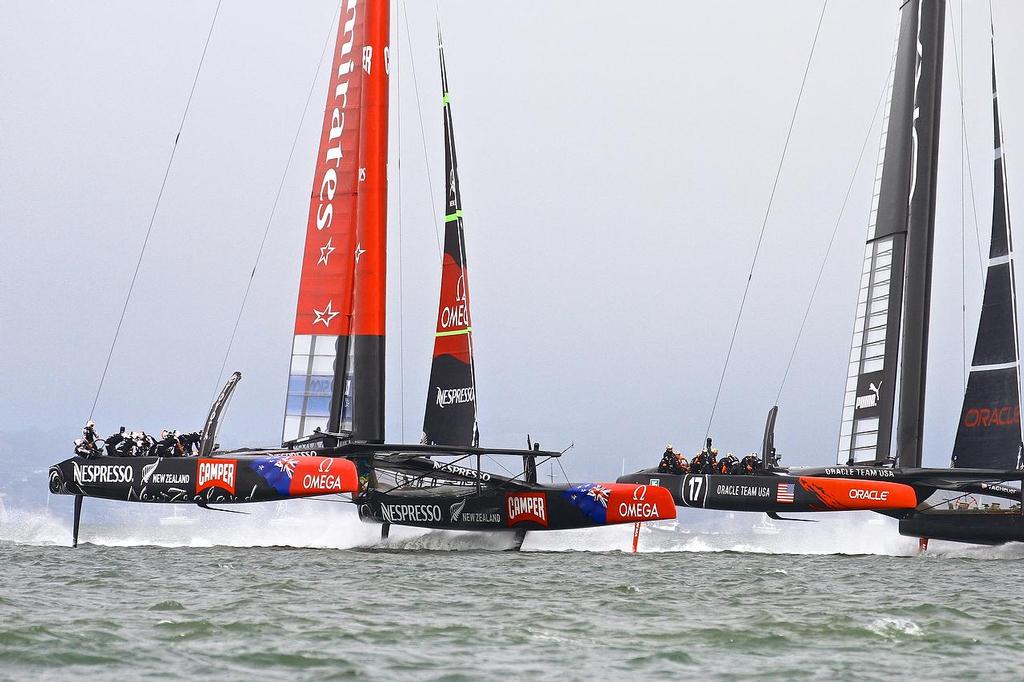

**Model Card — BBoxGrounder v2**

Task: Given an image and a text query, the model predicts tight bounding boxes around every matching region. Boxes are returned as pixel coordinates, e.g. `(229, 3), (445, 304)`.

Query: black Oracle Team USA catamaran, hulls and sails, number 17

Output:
(618, 0), (1024, 544)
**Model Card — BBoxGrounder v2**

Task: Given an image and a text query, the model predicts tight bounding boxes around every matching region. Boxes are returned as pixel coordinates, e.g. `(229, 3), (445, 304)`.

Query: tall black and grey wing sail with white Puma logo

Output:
(838, 0), (945, 466)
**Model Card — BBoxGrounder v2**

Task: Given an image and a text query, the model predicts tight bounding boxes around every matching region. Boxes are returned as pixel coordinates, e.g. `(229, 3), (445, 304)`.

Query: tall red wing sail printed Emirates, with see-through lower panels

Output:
(283, 0), (389, 440)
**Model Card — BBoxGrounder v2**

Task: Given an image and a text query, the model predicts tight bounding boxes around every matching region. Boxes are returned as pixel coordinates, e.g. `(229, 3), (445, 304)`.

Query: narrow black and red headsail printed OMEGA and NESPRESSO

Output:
(423, 33), (479, 445)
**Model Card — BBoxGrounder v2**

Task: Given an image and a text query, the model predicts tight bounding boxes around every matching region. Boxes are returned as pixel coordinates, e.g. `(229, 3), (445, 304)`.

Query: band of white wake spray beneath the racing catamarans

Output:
(6, 493), (1024, 560)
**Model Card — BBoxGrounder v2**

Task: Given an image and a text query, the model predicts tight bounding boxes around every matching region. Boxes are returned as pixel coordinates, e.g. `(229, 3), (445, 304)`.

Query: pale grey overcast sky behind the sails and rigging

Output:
(0, 0), (1024, 477)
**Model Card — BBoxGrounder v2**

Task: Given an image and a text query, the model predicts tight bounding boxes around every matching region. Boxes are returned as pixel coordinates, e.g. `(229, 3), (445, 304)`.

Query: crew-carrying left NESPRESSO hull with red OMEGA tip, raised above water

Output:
(49, 453), (358, 505)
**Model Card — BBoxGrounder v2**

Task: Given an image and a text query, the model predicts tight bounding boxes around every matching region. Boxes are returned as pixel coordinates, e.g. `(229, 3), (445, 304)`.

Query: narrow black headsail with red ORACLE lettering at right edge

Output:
(952, 30), (1021, 469)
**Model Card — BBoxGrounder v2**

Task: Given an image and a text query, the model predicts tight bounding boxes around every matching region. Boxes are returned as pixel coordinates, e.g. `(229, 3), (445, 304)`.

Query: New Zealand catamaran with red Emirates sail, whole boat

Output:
(49, 0), (676, 544)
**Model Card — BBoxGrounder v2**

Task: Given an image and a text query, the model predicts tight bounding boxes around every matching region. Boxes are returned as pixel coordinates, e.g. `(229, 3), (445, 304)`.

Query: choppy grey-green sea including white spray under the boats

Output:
(0, 503), (1024, 680)
